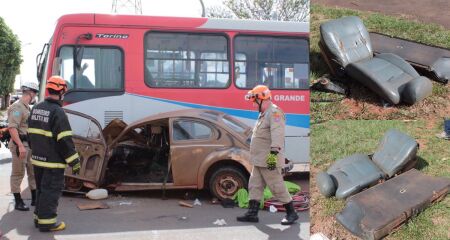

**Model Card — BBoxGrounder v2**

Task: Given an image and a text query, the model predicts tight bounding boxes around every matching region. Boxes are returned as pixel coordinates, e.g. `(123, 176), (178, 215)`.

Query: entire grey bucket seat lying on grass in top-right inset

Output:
(319, 16), (432, 104)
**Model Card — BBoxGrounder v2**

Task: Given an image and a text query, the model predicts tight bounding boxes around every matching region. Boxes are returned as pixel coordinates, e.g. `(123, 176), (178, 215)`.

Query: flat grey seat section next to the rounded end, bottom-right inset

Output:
(327, 154), (384, 199)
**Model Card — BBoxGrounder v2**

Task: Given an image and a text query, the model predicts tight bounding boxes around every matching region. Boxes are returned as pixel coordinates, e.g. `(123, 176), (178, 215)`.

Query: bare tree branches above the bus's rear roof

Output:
(208, 0), (309, 22)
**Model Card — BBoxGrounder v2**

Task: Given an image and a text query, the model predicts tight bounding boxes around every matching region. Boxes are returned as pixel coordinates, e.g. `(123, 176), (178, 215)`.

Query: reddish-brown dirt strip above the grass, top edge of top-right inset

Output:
(312, 0), (450, 29)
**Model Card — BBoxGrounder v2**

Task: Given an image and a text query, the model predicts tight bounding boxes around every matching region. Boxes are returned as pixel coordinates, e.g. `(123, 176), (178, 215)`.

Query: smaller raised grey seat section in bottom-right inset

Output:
(372, 129), (419, 177)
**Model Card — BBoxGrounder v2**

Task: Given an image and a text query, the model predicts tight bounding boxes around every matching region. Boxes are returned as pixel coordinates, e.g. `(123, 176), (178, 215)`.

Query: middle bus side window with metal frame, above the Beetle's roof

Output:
(144, 32), (230, 88)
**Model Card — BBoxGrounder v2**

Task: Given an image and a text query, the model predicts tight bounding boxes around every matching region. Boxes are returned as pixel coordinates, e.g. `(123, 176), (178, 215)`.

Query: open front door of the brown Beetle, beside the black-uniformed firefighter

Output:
(65, 109), (107, 187)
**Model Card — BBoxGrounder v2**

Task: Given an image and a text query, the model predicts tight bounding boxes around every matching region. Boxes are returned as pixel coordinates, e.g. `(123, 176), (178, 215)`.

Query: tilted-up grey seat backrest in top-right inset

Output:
(320, 16), (373, 67)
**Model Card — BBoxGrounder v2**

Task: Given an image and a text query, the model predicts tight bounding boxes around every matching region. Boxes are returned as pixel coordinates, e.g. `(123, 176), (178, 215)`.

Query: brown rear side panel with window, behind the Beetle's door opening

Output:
(170, 118), (223, 186)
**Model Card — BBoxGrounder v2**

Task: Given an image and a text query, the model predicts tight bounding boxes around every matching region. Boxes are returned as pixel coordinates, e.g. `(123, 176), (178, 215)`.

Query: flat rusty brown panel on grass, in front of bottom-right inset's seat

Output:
(336, 169), (450, 240)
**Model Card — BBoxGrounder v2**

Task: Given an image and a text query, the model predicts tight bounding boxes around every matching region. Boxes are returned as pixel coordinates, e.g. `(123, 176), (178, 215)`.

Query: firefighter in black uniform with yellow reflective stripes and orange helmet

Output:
(28, 76), (80, 232)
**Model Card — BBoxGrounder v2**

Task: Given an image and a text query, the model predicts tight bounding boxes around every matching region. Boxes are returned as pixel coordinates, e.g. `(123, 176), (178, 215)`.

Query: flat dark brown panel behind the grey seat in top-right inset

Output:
(369, 32), (450, 83)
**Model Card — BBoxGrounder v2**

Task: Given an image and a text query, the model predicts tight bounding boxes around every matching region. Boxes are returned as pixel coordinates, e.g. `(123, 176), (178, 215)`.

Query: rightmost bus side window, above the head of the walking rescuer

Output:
(234, 35), (309, 89)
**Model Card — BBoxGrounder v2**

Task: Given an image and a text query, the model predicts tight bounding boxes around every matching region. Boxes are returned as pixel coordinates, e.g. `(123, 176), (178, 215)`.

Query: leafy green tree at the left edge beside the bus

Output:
(0, 17), (22, 110)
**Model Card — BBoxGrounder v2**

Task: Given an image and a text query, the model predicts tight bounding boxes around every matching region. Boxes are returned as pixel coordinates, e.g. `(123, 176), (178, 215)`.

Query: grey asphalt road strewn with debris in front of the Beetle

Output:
(0, 146), (310, 240)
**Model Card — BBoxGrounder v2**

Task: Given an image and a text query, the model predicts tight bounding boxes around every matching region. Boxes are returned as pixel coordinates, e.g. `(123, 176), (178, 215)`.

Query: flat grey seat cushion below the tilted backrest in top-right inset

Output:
(345, 53), (429, 104)
